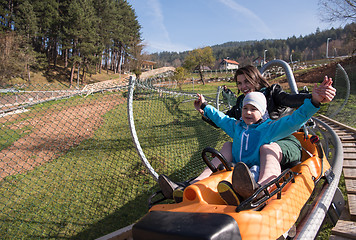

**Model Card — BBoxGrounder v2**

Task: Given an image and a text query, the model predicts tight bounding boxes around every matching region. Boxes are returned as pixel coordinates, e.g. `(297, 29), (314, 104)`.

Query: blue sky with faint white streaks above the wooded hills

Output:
(128, 0), (340, 53)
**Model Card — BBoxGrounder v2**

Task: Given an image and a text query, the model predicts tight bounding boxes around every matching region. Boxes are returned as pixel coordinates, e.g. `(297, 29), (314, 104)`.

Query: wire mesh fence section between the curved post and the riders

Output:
(129, 78), (232, 181)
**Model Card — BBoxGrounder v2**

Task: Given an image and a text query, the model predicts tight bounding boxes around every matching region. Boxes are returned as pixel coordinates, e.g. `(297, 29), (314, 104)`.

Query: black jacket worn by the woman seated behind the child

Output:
(203, 84), (312, 127)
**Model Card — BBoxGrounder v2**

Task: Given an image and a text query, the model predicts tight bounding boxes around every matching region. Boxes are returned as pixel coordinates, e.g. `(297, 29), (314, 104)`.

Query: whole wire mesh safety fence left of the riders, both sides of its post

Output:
(0, 59), (354, 239)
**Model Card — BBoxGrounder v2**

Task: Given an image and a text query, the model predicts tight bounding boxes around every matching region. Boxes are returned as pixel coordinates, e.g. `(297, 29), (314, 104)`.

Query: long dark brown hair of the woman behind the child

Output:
(234, 65), (270, 93)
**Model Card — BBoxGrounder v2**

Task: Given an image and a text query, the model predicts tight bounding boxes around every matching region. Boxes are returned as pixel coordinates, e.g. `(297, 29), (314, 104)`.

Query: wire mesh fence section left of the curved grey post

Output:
(0, 79), (149, 239)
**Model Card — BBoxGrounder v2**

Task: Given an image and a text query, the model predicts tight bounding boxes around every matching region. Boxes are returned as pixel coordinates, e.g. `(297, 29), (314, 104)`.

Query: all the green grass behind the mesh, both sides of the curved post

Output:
(0, 89), (228, 239)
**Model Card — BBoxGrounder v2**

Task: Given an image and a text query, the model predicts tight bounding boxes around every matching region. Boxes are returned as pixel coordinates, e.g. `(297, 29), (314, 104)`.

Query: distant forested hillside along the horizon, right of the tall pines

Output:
(152, 23), (356, 67)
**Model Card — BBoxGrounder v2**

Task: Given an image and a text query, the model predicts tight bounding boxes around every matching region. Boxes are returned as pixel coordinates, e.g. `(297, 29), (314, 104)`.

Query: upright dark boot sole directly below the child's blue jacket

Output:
(232, 162), (260, 199)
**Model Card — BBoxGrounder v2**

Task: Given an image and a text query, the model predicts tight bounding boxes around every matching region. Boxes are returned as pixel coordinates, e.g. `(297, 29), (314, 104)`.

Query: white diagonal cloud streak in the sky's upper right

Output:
(218, 0), (274, 38)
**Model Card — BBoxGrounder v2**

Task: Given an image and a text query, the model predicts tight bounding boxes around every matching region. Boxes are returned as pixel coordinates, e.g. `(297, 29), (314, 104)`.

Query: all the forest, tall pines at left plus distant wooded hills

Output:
(0, 0), (356, 86)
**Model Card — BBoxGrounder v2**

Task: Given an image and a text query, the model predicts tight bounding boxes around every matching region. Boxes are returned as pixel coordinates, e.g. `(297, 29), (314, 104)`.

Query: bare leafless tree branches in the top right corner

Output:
(319, 0), (356, 24)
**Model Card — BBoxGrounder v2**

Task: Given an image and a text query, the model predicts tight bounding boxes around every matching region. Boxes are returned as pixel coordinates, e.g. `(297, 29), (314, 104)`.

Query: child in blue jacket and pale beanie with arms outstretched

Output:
(194, 78), (332, 205)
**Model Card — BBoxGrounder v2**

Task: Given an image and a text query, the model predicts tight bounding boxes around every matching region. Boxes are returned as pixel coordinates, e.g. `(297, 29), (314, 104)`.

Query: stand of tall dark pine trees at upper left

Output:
(0, 0), (143, 85)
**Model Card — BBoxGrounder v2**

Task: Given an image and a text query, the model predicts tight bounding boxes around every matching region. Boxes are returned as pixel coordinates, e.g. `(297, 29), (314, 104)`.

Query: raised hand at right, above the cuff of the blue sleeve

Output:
(312, 76), (336, 104)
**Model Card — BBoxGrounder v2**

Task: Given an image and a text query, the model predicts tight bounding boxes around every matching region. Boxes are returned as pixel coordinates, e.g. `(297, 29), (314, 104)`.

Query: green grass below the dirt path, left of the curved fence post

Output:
(0, 99), (149, 239)
